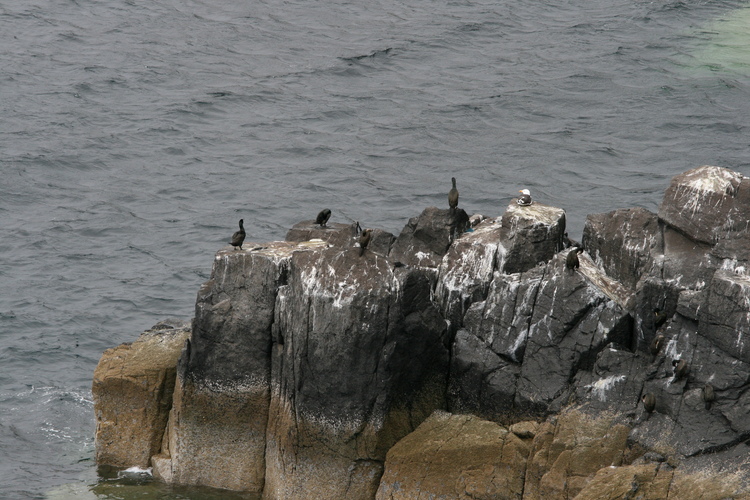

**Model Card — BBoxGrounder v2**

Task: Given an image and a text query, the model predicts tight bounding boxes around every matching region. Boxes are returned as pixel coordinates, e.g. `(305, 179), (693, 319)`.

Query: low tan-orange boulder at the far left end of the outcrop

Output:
(91, 320), (190, 468)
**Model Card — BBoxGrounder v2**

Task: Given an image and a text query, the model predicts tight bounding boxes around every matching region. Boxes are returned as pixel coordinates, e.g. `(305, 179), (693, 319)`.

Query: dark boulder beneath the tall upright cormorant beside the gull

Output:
(390, 207), (469, 268)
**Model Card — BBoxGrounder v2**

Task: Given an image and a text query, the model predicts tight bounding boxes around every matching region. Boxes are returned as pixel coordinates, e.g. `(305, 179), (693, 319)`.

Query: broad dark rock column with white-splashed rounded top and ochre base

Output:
(264, 247), (449, 498)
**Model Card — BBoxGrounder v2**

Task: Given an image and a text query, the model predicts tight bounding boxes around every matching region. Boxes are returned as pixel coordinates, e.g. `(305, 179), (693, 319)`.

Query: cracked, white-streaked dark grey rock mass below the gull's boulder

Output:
(450, 254), (632, 420)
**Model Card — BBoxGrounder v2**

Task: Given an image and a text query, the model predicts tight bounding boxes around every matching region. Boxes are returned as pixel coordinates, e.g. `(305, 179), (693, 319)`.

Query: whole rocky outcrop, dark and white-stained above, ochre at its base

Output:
(93, 166), (750, 500)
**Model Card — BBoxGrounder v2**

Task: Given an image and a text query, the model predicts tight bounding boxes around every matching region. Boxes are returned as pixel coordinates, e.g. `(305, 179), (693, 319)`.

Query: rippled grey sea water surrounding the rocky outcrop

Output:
(0, 0), (750, 499)
